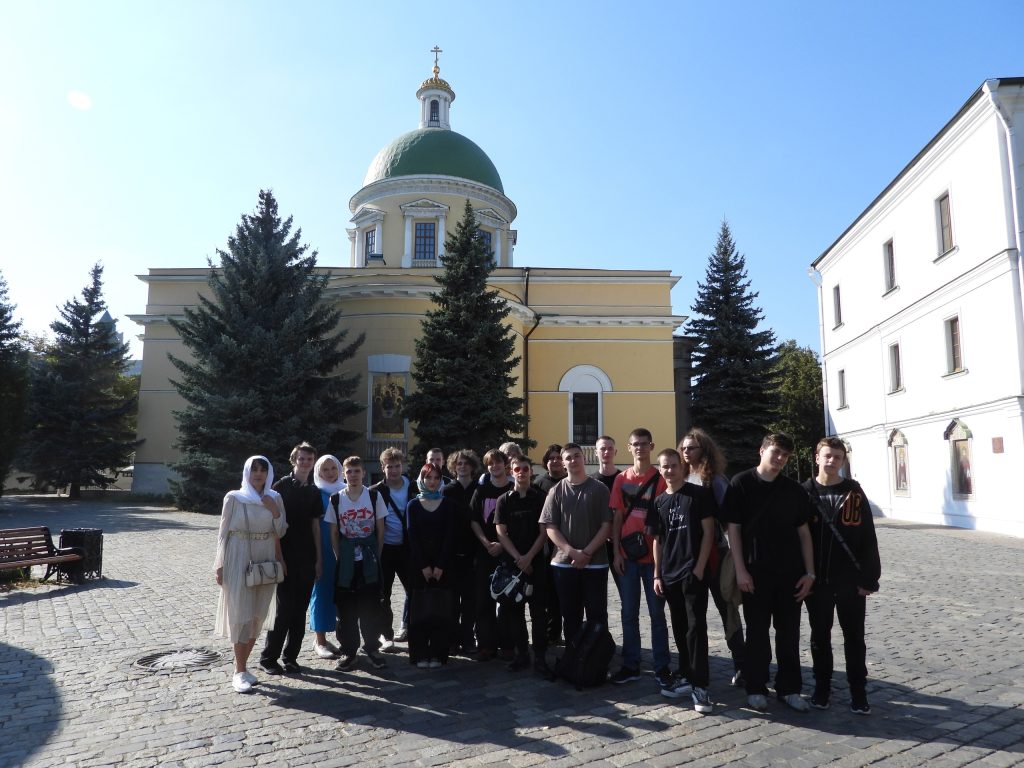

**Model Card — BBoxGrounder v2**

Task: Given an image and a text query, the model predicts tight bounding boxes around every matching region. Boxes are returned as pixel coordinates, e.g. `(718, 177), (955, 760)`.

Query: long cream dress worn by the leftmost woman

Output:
(213, 494), (288, 643)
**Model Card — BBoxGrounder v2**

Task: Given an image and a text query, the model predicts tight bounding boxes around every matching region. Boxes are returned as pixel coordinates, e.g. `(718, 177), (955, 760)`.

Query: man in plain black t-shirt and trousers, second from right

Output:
(725, 432), (815, 712)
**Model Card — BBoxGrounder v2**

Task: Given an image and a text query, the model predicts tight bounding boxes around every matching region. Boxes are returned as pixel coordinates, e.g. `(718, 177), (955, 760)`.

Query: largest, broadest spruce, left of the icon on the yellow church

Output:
(171, 190), (362, 512)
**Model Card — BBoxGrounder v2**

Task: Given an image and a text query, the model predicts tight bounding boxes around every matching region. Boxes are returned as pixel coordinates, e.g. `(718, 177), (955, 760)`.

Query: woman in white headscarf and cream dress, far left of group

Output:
(213, 456), (288, 693)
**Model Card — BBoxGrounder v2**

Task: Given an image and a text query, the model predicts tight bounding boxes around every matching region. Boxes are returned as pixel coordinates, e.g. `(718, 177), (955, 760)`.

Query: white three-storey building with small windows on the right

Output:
(811, 78), (1024, 536)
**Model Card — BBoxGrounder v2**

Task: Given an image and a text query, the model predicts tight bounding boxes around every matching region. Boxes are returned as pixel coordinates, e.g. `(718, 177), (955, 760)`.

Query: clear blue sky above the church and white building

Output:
(0, 0), (1024, 353)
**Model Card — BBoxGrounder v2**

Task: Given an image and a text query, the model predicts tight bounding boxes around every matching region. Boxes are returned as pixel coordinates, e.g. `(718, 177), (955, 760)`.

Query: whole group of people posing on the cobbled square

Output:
(215, 428), (881, 715)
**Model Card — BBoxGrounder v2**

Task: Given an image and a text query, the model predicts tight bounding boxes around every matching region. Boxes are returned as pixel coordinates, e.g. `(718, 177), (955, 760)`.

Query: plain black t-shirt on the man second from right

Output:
(725, 469), (811, 574)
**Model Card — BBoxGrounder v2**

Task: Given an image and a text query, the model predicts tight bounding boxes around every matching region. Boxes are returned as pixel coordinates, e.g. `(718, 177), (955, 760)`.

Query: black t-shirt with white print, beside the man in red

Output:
(647, 482), (715, 584)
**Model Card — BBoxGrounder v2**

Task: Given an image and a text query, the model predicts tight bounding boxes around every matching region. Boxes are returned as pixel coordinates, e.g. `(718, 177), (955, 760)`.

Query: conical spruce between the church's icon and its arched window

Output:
(402, 200), (526, 463)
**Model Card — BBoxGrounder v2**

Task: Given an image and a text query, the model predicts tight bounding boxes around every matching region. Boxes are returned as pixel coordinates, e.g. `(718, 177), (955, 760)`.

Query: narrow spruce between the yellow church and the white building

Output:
(687, 221), (775, 469)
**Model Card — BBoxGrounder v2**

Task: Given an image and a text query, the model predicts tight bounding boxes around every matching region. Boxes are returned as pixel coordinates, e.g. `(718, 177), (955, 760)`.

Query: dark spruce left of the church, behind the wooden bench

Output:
(18, 264), (137, 499)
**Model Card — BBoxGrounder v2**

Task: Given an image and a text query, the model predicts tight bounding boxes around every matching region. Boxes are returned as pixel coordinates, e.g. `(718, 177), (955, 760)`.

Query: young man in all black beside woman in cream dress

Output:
(259, 442), (324, 675)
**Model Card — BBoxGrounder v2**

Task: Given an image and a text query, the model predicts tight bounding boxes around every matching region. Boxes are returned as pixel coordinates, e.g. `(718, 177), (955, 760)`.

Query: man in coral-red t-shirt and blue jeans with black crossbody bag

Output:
(610, 427), (676, 692)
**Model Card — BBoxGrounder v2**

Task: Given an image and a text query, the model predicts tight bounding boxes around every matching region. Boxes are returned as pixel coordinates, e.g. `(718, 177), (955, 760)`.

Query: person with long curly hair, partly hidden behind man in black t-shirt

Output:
(677, 427), (743, 687)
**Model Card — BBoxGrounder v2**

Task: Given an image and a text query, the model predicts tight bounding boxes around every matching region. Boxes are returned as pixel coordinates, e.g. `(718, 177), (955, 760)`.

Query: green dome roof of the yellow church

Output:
(362, 128), (505, 195)
